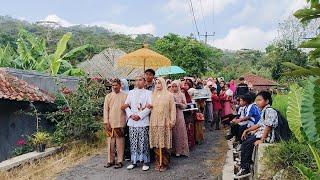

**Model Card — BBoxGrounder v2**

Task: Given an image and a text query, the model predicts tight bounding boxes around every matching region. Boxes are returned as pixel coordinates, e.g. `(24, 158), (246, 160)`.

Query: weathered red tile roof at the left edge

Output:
(0, 70), (55, 103)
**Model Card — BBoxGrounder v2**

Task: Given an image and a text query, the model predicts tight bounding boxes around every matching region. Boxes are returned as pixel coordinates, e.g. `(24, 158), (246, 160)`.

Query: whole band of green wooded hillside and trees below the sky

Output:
(0, 16), (307, 80)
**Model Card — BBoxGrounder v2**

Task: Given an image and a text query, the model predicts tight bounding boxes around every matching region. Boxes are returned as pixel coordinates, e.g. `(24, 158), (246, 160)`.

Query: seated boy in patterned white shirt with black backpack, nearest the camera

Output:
(235, 91), (278, 178)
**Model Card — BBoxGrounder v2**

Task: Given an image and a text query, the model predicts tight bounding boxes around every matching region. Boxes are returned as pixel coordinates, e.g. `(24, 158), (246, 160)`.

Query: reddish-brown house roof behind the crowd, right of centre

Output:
(236, 73), (279, 91)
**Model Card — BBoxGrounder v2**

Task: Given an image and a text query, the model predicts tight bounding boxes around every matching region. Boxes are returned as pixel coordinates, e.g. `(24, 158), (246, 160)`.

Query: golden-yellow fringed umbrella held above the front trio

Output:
(117, 44), (171, 70)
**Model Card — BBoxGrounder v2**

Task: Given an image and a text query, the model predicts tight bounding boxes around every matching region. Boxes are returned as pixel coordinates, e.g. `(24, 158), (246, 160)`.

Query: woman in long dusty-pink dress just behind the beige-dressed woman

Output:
(171, 80), (189, 157)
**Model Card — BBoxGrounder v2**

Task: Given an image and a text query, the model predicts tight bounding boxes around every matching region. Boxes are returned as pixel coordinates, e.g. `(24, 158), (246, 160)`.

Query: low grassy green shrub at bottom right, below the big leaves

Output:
(264, 140), (316, 179)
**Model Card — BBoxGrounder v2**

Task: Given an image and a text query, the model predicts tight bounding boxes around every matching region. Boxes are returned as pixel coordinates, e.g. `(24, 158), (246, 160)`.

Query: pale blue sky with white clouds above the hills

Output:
(0, 0), (306, 50)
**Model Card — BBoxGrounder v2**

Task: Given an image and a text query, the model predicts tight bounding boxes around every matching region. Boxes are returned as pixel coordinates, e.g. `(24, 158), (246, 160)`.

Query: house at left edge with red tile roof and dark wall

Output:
(0, 69), (55, 161)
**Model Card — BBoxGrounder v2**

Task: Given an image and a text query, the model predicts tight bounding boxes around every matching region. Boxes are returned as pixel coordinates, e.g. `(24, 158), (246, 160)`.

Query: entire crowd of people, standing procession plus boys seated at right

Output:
(104, 69), (277, 177)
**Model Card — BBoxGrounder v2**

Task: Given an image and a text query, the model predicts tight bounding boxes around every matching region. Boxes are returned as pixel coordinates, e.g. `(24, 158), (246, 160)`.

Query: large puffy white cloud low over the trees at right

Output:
(211, 26), (276, 50)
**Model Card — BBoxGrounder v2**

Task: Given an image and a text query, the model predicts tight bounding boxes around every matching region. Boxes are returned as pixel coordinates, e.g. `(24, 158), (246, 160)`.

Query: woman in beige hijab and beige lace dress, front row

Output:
(149, 77), (176, 172)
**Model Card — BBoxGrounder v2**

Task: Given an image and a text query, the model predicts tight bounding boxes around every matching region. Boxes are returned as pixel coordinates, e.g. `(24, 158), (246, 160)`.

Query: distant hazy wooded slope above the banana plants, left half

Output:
(0, 16), (157, 59)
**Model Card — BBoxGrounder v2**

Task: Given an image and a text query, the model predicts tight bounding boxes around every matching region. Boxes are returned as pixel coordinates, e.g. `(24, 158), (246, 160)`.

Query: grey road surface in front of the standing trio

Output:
(57, 128), (227, 180)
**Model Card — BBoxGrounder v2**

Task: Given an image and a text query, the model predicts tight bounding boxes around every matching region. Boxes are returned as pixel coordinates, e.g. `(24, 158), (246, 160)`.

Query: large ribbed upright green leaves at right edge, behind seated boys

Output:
(287, 77), (320, 179)
